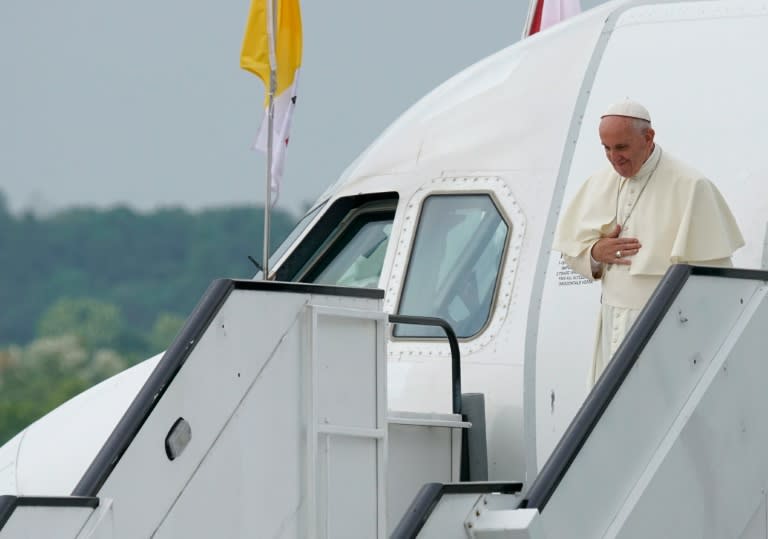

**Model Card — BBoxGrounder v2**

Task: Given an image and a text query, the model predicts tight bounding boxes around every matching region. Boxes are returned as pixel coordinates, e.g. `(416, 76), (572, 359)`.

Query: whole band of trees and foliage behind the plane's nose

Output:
(0, 195), (296, 444)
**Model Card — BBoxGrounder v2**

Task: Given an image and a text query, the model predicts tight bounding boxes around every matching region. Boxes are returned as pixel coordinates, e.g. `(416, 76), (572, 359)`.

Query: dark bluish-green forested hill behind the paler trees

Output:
(0, 202), (295, 344)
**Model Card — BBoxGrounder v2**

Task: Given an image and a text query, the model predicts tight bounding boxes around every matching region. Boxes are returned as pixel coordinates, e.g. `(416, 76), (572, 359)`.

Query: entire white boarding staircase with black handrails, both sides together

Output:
(0, 265), (768, 539)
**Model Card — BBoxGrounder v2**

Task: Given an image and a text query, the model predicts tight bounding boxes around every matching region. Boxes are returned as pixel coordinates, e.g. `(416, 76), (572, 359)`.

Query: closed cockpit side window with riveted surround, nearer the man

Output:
(395, 194), (509, 338)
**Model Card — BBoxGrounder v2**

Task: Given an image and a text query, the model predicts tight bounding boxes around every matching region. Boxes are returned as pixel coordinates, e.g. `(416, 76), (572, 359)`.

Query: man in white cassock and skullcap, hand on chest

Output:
(553, 100), (744, 387)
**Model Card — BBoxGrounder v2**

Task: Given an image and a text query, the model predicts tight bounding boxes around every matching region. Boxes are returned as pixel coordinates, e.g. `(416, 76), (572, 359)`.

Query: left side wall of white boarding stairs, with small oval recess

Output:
(0, 280), (471, 539)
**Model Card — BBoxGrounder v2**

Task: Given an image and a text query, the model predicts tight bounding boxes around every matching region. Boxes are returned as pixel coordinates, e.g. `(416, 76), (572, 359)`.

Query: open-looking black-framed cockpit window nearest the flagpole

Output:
(276, 193), (397, 288)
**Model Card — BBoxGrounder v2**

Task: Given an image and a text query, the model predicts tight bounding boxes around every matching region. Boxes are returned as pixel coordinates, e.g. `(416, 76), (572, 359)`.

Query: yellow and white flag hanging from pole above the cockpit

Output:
(240, 0), (301, 204)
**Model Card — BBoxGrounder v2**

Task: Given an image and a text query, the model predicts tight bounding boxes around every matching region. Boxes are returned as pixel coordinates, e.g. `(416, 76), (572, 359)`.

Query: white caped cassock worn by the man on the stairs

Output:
(553, 144), (744, 387)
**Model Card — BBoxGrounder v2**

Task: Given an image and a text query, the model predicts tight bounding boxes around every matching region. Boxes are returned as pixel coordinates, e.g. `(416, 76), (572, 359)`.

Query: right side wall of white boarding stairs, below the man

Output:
(392, 265), (768, 539)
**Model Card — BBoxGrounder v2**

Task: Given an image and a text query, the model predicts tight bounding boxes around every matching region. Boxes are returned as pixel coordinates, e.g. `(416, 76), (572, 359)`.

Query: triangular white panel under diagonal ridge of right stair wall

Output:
(609, 287), (768, 538)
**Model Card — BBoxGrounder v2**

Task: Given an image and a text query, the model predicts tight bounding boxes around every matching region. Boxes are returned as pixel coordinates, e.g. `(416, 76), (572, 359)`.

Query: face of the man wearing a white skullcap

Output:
(600, 116), (654, 178)
